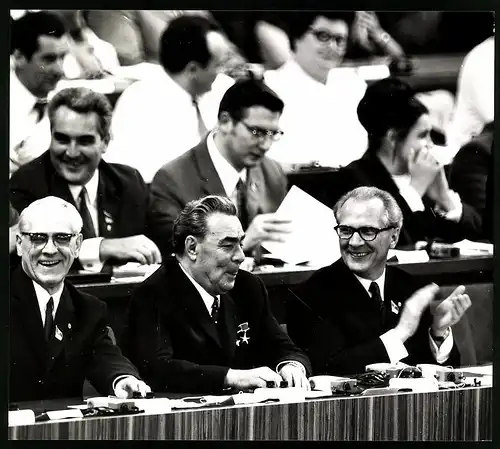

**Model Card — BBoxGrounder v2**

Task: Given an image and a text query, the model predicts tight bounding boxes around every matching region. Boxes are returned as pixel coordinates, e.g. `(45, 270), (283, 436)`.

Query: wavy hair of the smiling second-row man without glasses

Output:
(47, 87), (113, 141)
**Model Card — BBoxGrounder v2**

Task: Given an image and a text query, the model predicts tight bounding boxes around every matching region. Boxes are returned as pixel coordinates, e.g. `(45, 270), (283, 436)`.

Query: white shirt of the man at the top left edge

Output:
(9, 69), (51, 177)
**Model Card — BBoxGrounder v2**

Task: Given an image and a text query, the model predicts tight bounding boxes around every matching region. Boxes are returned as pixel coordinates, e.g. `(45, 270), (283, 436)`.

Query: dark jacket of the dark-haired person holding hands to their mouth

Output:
(332, 152), (481, 247)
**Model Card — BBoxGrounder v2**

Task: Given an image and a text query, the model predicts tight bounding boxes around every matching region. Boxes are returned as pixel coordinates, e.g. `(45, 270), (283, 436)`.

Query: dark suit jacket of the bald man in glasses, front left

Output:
(9, 266), (139, 401)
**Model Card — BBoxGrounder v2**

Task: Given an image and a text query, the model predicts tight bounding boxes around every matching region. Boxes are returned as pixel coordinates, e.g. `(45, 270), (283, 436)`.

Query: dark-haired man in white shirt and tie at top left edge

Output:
(9, 11), (68, 175)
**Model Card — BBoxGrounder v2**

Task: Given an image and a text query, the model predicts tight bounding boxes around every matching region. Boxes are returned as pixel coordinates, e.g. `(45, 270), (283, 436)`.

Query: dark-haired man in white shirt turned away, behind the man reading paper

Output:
(106, 15), (233, 182)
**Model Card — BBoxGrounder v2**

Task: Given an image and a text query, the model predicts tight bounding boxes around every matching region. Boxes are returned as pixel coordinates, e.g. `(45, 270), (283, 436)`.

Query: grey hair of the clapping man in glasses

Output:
(333, 186), (403, 229)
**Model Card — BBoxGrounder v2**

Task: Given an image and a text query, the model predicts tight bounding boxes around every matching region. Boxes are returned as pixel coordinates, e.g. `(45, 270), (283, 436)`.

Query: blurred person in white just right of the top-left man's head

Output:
(51, 9), (120, 79)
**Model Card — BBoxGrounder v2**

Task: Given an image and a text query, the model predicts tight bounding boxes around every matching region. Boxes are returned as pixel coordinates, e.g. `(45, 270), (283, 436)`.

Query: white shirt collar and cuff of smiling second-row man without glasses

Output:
(69, 170), (103, 271)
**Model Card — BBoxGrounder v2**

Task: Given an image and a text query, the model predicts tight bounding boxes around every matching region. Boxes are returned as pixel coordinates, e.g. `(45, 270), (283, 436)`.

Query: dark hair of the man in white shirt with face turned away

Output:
(159, 15), (221, 74)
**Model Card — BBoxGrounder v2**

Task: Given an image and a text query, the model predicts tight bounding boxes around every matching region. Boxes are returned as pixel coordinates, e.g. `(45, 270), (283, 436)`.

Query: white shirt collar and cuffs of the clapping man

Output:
(353, 270), (453, 363)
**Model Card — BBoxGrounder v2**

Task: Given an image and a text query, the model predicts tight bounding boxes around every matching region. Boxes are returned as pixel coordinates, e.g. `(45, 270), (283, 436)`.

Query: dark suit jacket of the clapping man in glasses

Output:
(288, 259), (460, 375)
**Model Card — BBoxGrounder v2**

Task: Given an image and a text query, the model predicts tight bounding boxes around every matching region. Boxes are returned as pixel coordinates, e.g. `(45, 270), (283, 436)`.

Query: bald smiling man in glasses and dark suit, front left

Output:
(9, 196), (150, 401)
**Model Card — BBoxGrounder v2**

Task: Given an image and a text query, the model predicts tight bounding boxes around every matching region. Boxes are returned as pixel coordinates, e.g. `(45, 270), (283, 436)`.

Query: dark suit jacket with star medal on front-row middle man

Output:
(124, 257), (310, 393)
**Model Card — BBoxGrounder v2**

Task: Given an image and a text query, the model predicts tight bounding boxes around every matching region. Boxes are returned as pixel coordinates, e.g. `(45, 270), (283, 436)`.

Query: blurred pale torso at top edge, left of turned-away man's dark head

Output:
(84, 9), (210, 66)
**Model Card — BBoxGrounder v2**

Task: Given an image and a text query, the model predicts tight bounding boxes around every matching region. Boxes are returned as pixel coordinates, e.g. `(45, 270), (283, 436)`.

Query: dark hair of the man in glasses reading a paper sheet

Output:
(218, 79), (285, 122)
